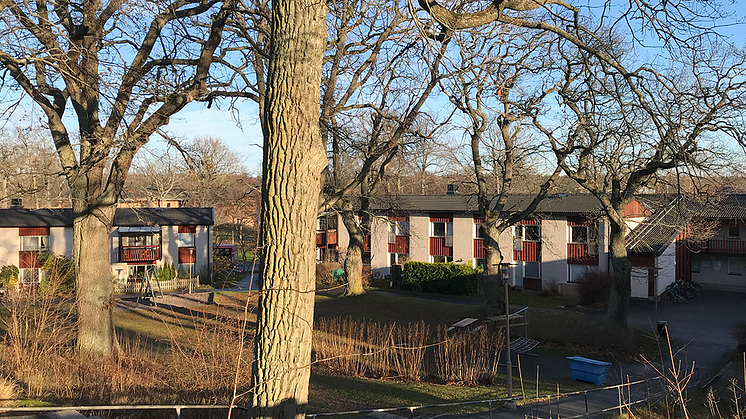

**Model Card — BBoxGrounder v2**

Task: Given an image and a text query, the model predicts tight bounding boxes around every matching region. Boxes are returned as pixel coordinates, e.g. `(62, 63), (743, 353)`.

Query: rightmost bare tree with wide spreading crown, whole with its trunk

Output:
(534, 40), (746, 328)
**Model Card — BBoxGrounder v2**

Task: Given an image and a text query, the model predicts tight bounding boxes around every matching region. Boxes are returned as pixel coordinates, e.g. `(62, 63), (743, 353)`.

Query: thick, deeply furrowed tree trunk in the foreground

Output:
(251, 0), (327, 419)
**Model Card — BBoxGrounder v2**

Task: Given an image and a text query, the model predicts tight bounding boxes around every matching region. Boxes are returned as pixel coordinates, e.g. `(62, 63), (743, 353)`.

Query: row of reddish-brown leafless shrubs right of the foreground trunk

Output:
(314, 317), (503, 385)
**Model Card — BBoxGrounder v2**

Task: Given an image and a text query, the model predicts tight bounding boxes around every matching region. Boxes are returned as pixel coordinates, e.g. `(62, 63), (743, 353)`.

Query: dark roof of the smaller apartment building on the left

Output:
(0, 208), (214, 227)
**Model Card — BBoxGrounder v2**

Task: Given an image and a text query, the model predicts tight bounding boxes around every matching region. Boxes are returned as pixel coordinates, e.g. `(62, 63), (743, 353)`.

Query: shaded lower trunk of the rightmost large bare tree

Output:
(607, 221), (632, 329)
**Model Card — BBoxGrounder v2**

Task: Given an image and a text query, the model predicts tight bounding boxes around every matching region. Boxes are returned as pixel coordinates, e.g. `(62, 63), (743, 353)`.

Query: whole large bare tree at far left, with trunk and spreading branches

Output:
(0, 0), (237, 359)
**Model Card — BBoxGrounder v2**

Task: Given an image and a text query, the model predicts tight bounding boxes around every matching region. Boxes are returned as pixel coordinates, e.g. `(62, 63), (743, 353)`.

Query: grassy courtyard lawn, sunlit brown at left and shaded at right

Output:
(0, 292), (656, 414)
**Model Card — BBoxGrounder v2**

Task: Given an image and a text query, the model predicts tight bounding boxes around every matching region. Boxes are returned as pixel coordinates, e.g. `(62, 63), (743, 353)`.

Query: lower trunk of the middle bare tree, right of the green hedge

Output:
(483, 221), (505, 316)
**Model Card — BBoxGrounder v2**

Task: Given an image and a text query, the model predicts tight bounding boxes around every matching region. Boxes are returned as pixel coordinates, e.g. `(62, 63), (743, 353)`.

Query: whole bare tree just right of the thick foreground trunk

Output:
(321, 0), (448, 295)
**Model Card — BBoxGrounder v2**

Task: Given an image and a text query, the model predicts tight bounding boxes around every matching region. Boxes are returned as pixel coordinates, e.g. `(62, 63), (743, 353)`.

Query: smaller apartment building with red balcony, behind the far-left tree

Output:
(0, 208), (214, 284)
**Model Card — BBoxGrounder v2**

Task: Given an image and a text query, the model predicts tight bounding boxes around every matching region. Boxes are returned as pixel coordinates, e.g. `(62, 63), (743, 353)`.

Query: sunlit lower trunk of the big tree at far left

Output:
(73, 205), (116, 359)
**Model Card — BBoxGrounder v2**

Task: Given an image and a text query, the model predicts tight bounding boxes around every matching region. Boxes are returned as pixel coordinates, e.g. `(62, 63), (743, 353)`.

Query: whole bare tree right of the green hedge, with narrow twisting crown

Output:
(443, 28), (561, 315)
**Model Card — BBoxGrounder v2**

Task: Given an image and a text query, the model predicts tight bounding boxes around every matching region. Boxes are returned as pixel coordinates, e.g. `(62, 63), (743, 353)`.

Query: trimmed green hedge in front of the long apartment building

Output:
(403, 262), (482, 294)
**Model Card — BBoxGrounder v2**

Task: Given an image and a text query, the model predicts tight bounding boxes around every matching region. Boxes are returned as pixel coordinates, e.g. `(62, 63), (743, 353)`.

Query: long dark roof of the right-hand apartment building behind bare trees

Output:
(358, 194), (601, 214)
